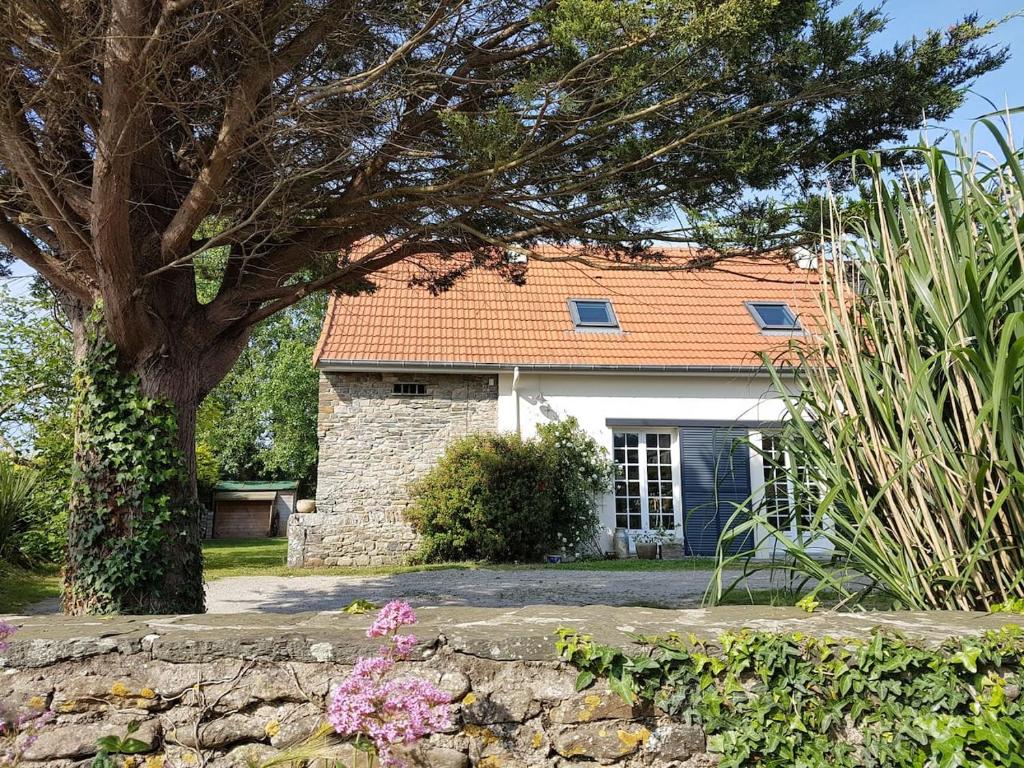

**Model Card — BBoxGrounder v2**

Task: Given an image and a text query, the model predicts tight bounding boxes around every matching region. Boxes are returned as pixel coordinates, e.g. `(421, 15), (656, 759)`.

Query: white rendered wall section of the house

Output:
(498, 373), (785, 550)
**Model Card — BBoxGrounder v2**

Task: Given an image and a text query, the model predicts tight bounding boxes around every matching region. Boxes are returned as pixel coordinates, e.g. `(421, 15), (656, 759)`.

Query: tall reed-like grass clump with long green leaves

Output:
(723, 121), (1024, 609)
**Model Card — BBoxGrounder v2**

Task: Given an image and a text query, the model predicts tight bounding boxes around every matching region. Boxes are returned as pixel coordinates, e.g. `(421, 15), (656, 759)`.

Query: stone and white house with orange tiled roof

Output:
(289, 248), (820, 565)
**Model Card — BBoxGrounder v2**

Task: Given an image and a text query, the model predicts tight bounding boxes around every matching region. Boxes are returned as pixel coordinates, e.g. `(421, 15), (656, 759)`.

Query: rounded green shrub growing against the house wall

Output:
(409, 420), (610, 562)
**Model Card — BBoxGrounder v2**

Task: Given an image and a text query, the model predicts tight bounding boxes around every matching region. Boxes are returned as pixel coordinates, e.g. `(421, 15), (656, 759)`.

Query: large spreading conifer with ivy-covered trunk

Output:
(0, 0), (1005, 611)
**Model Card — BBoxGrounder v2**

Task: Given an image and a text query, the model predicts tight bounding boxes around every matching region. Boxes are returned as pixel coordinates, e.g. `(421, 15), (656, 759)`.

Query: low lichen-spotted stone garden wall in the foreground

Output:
(0, 606), (1024, 768)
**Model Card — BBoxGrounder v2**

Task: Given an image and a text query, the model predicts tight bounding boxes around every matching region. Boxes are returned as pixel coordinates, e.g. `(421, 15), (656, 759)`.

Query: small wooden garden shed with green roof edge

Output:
(213, 480), (299, 539)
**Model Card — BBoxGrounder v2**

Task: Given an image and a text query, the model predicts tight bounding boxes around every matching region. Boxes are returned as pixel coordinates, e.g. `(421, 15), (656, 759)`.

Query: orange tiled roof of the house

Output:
(315, 243), (820, 368)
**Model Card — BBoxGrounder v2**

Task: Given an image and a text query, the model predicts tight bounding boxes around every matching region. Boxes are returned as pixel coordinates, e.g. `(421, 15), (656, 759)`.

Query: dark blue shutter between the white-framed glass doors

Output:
(679, 427), (753, 556)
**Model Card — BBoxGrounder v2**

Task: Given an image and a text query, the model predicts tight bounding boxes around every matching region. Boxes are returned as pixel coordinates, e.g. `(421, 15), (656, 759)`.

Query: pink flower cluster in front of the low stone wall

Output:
(328, 600), (452, 766)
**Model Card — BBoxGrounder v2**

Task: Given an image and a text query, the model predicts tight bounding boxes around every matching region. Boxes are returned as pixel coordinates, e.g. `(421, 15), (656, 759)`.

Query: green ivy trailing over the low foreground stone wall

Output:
(558, 627), (1024, 768)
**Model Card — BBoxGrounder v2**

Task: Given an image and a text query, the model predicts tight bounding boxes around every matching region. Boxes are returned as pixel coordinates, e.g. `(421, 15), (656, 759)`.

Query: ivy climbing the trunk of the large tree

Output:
(63, 311), (204, 613)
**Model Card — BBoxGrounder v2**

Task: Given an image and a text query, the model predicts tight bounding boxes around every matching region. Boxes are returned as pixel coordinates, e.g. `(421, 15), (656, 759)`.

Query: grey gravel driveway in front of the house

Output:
(199, 568), (771, 613)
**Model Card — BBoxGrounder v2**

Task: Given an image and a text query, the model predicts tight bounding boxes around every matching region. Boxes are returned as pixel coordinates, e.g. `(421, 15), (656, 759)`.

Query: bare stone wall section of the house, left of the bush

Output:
(288, 373), (498, 566)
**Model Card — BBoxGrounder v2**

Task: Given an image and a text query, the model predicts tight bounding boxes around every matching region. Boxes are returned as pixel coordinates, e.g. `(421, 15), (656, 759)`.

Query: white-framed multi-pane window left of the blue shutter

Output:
(611, 429), (682, 530)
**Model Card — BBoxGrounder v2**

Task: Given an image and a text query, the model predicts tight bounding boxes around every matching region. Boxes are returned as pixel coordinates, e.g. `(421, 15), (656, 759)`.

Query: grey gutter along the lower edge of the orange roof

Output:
(315, 358), (796, 375)
